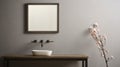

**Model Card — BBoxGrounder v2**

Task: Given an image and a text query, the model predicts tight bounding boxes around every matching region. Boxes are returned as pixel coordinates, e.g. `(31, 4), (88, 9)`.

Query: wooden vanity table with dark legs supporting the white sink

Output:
(2, 55), (88, 67)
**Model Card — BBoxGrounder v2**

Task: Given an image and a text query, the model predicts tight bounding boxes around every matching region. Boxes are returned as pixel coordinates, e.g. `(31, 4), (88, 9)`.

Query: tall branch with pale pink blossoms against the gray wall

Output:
(89, 23), (113, 67)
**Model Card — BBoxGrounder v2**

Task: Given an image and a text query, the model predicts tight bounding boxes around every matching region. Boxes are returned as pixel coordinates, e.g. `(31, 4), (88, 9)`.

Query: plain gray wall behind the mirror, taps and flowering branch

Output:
(0, 0), (120, 67)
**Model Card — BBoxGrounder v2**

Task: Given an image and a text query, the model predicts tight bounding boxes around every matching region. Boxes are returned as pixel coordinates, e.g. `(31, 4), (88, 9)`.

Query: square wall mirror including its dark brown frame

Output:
(25, 3), (59, 33)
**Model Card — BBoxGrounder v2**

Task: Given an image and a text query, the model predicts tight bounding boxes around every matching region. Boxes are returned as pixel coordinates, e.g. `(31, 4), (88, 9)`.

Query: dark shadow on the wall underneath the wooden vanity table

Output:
(0, 58), (79, 67)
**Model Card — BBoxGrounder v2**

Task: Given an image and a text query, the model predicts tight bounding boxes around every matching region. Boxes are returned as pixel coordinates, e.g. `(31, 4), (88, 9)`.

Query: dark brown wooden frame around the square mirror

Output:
(24, 3), (59, 34)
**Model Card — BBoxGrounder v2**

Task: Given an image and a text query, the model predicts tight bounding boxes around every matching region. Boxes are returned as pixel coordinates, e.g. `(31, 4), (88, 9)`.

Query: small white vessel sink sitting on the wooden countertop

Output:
(32, 50), (52, 56)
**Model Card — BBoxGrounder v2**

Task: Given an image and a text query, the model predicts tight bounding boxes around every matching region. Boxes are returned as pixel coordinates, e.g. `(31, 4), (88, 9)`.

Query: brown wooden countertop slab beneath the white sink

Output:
(2, 54), (88, 60)
